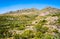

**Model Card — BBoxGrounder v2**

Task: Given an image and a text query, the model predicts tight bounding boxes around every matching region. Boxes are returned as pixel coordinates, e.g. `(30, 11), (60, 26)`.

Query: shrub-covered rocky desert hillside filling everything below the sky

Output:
(0, 7), (60, 39)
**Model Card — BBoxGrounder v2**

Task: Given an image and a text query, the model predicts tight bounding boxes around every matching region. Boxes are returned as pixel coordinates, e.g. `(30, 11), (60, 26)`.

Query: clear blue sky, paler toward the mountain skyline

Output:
(0, 0), (60, 14)
